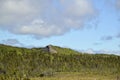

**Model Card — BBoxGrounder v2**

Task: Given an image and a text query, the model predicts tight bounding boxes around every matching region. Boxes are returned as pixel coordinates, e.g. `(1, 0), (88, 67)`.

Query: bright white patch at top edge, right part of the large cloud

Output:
(61, 0), (94, 17)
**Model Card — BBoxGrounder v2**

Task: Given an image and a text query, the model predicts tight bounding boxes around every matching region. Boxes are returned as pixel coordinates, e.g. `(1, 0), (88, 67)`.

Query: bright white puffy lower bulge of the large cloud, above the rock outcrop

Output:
(13, 20), (64, 37)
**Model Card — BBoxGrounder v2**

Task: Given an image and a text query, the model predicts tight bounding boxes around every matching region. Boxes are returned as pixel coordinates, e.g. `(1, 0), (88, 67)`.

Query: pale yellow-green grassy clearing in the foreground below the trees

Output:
(31, 72), (119, 80)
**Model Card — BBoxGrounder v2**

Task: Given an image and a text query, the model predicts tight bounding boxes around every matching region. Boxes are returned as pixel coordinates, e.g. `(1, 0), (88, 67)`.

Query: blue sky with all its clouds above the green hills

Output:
(0, 0), (120, 55)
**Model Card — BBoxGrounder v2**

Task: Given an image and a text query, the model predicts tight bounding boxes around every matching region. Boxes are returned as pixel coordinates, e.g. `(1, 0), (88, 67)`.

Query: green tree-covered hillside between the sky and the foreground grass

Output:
(0, 45), (120, 80)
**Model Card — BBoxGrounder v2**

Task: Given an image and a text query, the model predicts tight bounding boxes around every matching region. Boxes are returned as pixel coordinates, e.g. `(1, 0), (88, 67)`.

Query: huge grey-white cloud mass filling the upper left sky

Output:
(0, 0), (96, 38)
